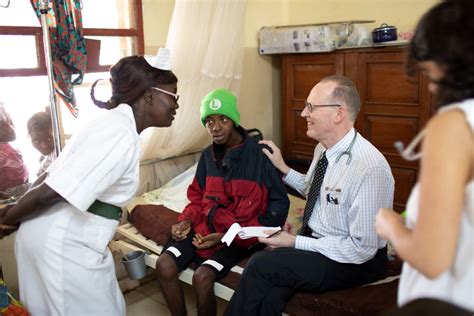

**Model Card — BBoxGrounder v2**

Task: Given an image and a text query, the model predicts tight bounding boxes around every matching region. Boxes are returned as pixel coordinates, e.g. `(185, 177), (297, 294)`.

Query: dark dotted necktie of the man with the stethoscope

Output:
(300, 152), (328, 236)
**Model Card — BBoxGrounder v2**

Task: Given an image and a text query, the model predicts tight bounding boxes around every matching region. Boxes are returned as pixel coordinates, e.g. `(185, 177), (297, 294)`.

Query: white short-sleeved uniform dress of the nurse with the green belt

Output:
(15, 104), (141, 316)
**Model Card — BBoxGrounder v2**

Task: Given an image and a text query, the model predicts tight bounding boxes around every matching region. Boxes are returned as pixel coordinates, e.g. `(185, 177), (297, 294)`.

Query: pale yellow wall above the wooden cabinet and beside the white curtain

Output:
(143, 0), (438, 144)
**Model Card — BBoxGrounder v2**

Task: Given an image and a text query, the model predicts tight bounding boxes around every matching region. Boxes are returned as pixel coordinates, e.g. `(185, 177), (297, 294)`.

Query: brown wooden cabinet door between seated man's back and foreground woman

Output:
(356, 49), (431, 210)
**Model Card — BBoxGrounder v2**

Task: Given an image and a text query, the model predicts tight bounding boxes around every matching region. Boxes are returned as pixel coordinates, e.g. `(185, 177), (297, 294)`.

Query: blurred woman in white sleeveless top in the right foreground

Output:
(376, 0), (474, 315)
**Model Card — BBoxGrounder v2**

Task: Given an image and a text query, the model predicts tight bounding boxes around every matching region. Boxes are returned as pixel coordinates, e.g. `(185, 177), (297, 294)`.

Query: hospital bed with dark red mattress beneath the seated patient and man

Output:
(110, 153), (401, 315)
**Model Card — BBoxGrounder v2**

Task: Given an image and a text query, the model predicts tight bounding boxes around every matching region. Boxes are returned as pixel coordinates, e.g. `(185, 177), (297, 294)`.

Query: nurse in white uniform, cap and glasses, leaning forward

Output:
(0, 50), (178, 316)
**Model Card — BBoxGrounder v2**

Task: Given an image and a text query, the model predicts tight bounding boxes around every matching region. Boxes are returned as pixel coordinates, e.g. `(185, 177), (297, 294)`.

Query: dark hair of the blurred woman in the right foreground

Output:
(407, 0), (474, 106)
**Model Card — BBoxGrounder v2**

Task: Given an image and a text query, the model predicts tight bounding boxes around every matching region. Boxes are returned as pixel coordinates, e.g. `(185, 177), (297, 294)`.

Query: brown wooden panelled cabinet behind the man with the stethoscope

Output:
(282, 47), (433, 210)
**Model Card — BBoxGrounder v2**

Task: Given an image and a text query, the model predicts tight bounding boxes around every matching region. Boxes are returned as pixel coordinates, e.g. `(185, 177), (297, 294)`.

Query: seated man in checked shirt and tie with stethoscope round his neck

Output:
(225, 76), (394, 315)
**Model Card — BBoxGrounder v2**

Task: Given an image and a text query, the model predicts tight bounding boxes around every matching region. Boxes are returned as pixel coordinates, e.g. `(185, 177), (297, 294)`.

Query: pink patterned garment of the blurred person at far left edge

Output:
(0, 143), (28, 191)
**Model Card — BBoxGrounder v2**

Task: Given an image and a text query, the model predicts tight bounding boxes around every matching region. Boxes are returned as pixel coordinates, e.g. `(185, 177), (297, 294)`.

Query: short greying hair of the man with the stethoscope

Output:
(320, 75), (360, 122)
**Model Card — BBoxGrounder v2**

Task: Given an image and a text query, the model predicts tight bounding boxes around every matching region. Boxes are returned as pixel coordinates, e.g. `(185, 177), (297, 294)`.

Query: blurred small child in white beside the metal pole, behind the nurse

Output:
(27, 108), (56, 177)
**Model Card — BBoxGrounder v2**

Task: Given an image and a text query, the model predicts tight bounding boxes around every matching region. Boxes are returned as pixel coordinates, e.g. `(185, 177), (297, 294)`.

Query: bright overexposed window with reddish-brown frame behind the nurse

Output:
(0, 0), (144, 181)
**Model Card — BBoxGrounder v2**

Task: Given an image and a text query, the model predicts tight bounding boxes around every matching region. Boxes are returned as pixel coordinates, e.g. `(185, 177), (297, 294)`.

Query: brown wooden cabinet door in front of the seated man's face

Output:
(282, 53), (344, 165)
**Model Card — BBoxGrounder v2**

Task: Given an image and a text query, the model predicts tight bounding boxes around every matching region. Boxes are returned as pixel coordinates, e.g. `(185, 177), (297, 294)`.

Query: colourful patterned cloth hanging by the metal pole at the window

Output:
(30, 0), (87, 117)
